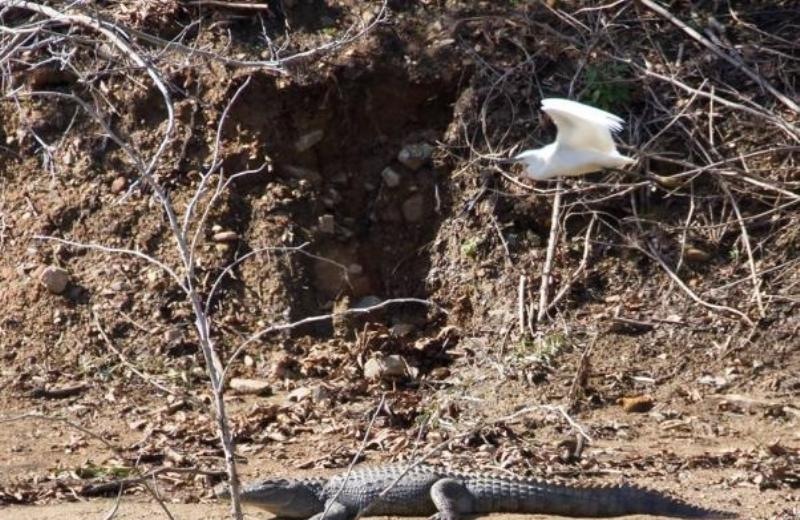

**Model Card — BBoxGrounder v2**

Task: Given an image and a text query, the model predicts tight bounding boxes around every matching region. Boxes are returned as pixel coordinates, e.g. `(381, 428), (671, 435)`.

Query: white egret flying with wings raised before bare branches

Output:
(514, 98), (636, 181)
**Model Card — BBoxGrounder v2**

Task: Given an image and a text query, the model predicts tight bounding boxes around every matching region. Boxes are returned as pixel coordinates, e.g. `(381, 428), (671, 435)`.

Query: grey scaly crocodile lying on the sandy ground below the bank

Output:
(217, 464), (739, 520)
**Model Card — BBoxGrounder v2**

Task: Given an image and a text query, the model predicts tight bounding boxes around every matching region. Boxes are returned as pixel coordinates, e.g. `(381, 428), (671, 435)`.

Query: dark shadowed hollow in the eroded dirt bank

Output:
(225, 67), (456, 335)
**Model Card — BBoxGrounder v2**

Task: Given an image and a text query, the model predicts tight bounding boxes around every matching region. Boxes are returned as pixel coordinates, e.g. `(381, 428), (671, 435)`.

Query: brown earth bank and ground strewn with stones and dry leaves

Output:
(0, 1), (800, 519)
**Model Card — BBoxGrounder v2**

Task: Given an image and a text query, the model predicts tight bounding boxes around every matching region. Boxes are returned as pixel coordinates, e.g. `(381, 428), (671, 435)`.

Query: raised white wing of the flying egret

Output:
(542, 98), (623, 152)
